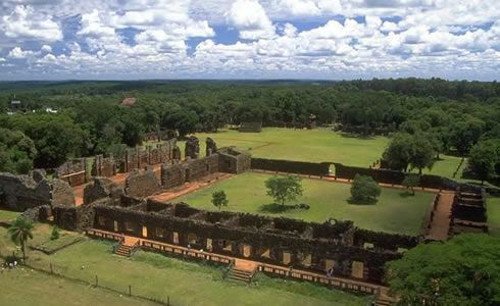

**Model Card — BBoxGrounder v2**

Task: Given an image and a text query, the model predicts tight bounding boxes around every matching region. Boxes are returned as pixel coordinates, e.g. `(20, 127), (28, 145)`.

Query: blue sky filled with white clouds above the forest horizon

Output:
(0, 0), (500, 80)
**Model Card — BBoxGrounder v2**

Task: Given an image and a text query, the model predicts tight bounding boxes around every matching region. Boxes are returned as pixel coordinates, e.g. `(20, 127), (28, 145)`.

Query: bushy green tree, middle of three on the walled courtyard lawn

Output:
(266, 176), (303, 205)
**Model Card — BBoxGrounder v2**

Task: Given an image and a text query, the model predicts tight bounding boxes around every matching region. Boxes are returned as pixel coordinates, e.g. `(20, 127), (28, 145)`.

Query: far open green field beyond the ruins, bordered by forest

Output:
(188, 128), (460, 178)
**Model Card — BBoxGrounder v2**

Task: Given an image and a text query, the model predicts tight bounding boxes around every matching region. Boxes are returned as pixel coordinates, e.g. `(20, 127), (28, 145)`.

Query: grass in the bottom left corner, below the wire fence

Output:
(0, 268), (157, 306)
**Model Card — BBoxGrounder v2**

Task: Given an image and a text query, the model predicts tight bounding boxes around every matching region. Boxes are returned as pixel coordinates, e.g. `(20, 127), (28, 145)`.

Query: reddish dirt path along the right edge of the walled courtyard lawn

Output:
(426, 191), (455, 240)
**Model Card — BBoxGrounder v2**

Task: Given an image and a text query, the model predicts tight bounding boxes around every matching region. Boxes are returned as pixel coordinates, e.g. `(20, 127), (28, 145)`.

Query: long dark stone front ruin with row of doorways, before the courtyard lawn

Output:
(81, 200), (406, 283)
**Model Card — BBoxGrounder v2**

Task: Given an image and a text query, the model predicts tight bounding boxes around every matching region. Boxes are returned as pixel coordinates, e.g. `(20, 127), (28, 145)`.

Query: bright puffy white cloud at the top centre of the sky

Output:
(227, 0), (276, 40)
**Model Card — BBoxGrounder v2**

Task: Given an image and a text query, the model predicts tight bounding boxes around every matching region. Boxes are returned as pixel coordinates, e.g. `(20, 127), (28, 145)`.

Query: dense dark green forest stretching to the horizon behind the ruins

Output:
(0, 78), (500, 185)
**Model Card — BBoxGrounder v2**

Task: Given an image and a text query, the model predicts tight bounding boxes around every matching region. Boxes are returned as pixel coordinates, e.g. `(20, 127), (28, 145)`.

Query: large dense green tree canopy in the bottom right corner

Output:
(387, 234), (500, 305)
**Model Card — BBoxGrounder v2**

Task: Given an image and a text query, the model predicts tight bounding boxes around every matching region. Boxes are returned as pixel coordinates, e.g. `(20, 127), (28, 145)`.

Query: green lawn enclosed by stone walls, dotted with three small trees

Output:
(175, 173), (434, 234)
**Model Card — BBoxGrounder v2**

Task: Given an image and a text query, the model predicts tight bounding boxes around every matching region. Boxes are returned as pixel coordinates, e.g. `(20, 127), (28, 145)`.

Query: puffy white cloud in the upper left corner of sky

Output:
(0, 5), (63, 42)
